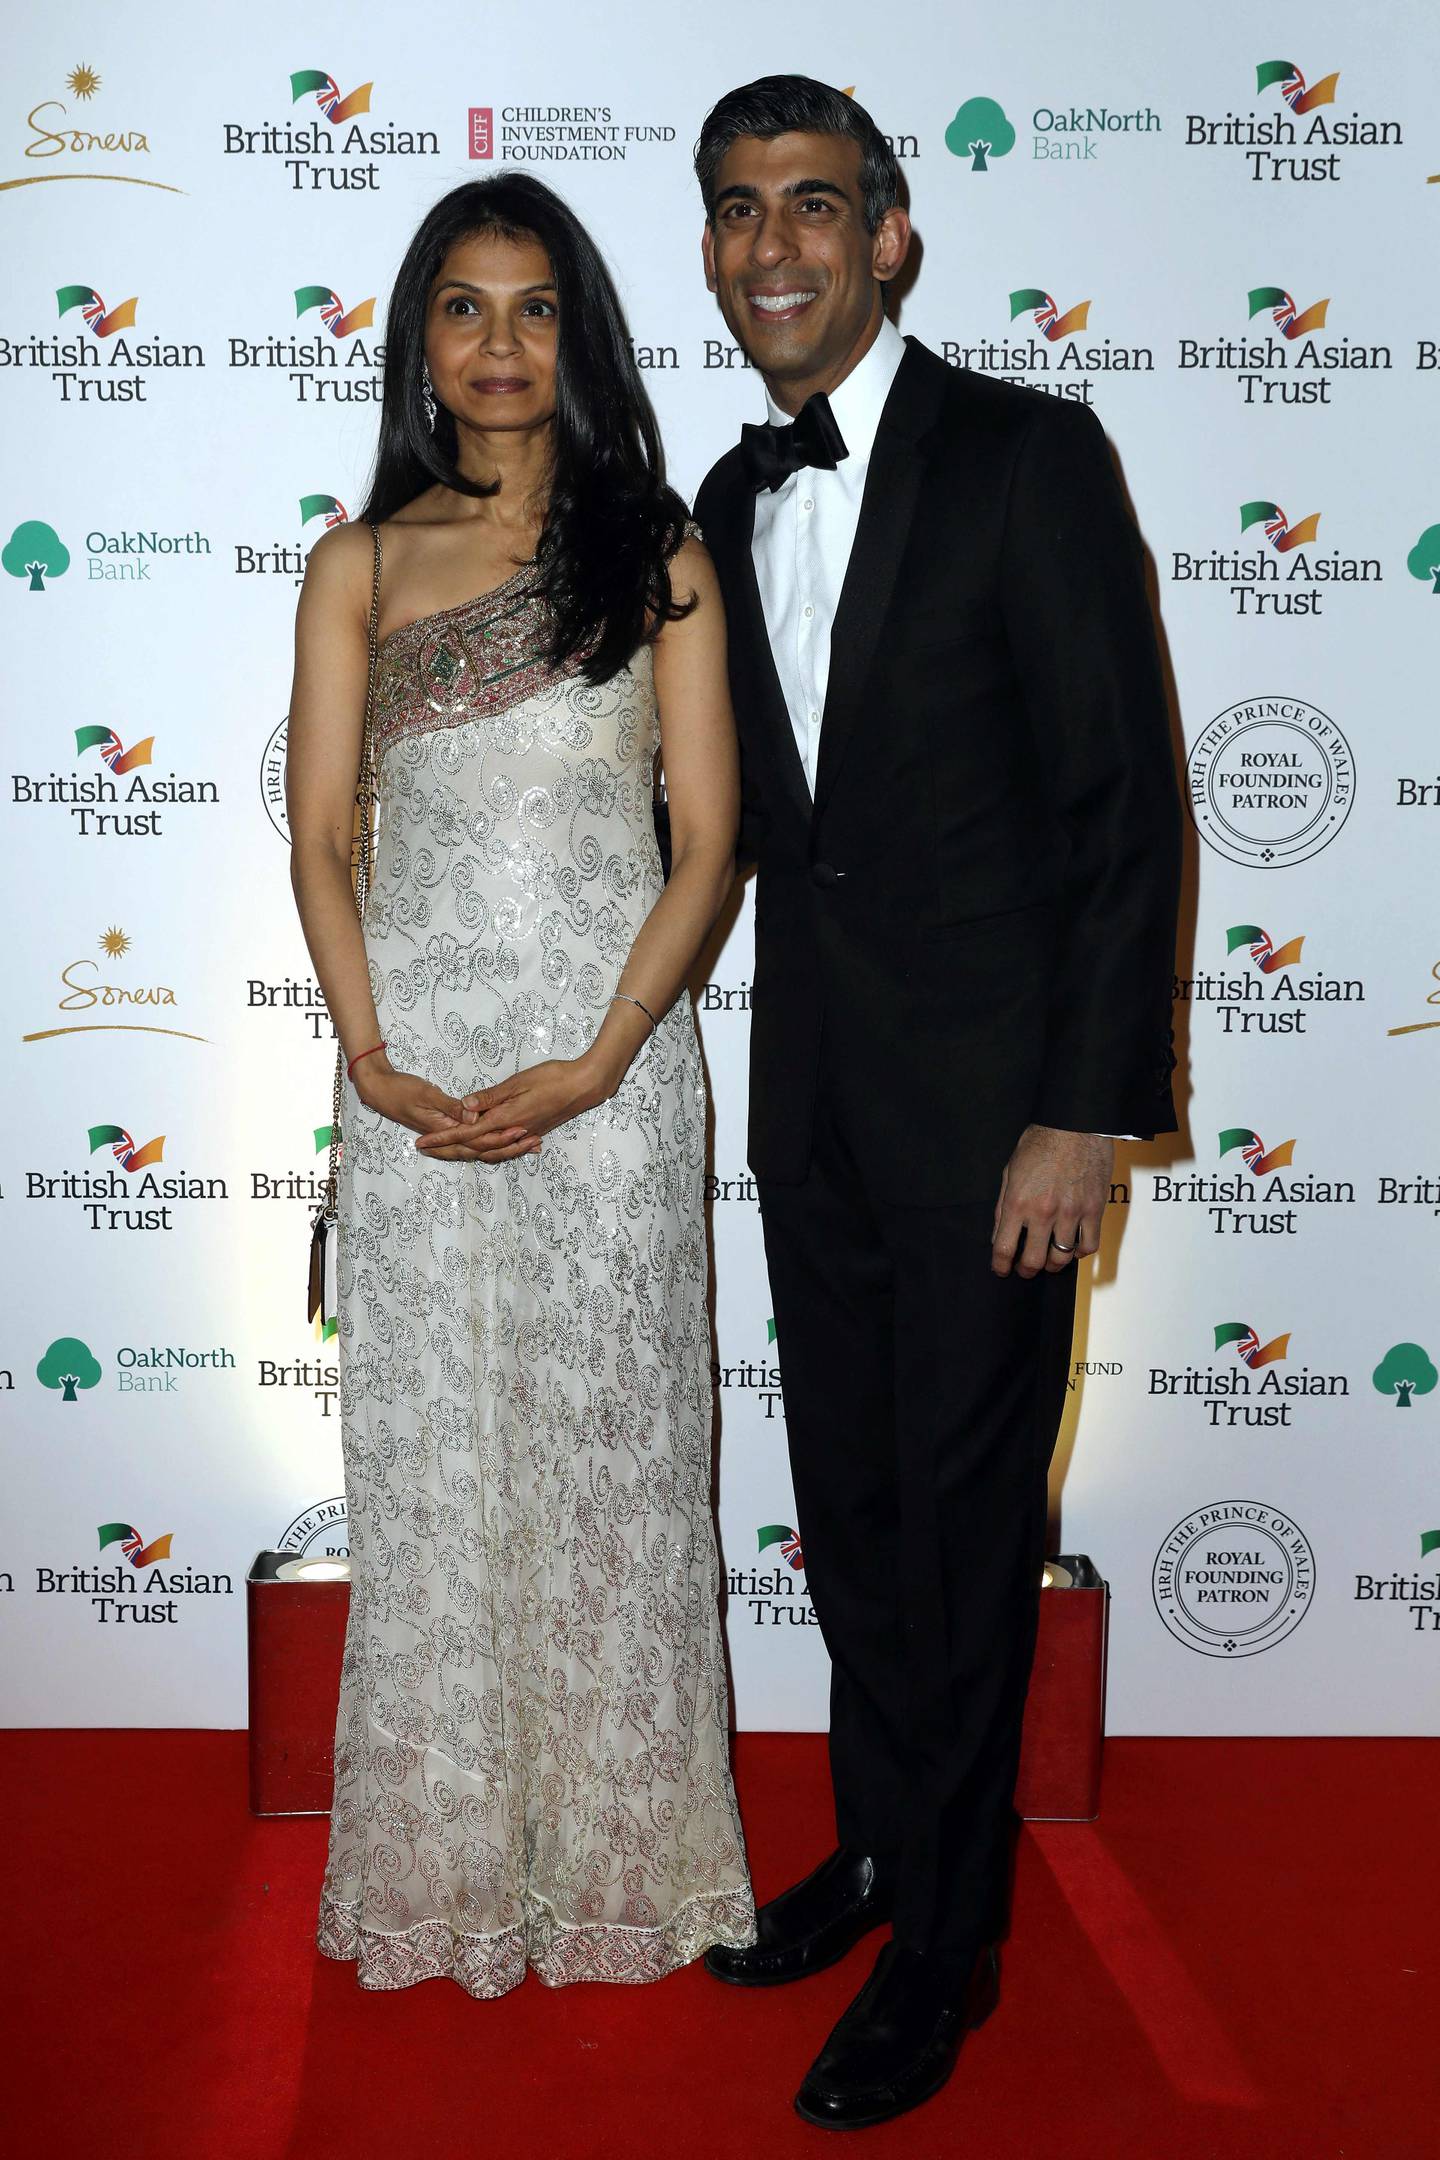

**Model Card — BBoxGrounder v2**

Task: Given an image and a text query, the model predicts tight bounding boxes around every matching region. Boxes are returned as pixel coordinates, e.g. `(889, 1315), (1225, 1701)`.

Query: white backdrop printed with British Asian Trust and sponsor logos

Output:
(0, 0), (1440, 1732)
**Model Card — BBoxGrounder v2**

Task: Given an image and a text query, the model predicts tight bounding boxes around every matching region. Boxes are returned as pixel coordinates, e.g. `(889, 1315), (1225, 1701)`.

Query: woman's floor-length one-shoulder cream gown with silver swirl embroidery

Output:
(320, 552), (753, 1996)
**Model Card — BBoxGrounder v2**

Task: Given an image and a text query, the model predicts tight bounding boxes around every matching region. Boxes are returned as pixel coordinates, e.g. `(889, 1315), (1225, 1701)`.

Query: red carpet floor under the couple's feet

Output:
(0, 1732), (1440, 2160)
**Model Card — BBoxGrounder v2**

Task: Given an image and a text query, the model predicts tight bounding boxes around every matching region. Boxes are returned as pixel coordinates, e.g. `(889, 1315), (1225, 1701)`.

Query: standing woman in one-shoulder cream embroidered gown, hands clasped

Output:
(289, 175), (753, 1996)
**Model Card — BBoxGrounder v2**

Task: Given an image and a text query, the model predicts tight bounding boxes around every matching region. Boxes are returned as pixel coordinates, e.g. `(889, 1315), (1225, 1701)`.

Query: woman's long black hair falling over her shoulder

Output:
(363, 173), (693, 683)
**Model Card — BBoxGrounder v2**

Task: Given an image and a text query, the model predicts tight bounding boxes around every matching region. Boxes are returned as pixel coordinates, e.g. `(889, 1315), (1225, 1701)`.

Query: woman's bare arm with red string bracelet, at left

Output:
(285, 525), (496, 1132)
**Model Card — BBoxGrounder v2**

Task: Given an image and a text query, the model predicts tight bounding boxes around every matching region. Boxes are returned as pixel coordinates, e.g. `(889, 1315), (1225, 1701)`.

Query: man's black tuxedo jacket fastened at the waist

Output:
(695, 339), (1179, 1205)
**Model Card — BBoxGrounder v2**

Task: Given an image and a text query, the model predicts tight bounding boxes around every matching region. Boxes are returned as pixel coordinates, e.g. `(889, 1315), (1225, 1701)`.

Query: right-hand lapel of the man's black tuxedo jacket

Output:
(816, 339), (946, 810)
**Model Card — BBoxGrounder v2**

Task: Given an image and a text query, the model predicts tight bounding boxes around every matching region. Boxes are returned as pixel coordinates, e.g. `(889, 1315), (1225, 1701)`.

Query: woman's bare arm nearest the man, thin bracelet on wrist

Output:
(419, 540), (741, 1162)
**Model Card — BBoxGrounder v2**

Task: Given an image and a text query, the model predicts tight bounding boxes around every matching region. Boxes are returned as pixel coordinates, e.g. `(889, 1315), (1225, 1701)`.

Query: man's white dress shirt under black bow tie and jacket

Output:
(751, 318), (905, 795)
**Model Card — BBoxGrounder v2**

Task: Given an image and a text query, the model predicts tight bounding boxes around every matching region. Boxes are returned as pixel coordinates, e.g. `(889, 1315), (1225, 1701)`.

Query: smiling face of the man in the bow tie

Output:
(702, 134), (909, 413)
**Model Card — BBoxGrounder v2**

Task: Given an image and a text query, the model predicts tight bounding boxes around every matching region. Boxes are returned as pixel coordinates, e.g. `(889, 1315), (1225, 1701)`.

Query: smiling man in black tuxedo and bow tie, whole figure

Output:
(695, 76), (1179, 2128)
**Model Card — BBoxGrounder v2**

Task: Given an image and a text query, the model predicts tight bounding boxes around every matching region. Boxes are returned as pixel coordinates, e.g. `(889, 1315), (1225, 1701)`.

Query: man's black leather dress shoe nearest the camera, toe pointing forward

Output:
(794, 1942), (1000, 2130)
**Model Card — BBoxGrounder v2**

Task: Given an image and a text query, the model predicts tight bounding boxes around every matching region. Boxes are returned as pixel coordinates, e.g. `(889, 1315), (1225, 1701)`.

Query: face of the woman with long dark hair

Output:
(425, 233), (559, 434)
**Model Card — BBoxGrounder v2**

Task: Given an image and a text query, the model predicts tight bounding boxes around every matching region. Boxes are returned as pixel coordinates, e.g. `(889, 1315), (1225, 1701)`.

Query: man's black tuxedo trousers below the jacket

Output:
(760, 1052), (1075, 1955)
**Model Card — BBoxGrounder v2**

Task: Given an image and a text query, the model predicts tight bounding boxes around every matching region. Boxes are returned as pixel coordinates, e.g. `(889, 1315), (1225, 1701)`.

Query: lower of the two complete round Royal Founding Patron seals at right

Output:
(1151, 1499), (1315, 1659)
